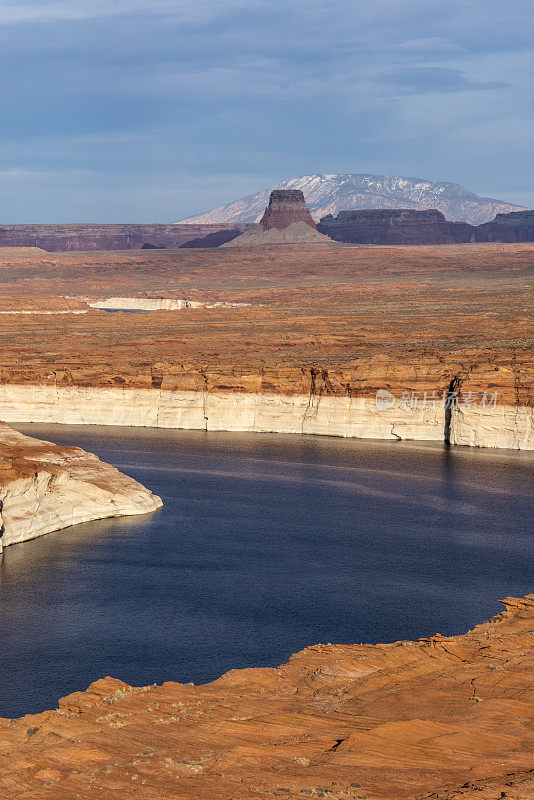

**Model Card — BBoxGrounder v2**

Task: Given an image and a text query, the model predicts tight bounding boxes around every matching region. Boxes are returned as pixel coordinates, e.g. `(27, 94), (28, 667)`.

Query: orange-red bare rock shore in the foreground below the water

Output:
(0, 595), (534, 800)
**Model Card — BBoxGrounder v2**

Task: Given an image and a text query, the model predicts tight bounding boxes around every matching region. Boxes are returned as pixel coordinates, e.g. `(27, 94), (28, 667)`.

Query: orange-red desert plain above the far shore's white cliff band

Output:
(0, 239), (534, 406)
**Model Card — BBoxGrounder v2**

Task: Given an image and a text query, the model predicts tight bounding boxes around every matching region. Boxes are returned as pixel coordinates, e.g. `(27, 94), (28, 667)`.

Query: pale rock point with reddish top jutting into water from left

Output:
(0, 422), (162, 552)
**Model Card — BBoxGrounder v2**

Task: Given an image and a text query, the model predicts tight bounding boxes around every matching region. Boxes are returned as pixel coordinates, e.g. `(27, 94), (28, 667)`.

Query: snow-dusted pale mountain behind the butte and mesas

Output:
(180, 173), (524, 225)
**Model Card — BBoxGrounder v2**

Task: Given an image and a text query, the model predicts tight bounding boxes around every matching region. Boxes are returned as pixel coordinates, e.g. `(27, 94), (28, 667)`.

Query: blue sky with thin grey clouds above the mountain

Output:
(0, 0), (534, 225)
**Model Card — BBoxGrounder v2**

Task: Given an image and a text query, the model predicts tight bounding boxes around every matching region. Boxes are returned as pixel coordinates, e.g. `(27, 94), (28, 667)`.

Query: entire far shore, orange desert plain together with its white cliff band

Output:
(0, 238), (534, 448)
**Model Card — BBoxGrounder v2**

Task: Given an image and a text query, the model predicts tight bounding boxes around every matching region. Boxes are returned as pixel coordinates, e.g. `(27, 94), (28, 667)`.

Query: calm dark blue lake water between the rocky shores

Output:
(0, 425), (534, 717)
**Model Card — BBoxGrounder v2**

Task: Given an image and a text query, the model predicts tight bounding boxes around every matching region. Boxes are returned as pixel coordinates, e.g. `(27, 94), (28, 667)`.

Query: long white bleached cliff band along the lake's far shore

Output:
(0, 384), (534, 450)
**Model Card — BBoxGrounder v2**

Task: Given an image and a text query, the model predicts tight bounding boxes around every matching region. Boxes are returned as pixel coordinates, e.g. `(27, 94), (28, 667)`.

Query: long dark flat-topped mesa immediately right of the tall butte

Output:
(317, 208), (474, 244)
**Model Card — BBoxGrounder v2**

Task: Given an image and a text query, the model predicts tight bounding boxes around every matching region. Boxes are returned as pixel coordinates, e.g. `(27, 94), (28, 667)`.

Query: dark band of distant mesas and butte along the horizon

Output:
(0, 209), (534, 252)
